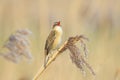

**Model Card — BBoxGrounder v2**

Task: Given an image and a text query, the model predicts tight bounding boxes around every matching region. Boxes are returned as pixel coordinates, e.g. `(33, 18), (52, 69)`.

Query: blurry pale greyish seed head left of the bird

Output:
(3, 29), (32, 63)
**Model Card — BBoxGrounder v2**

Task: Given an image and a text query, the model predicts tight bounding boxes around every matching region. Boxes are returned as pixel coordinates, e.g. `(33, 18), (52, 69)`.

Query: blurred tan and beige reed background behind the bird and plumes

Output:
(0, 0), (120, 80)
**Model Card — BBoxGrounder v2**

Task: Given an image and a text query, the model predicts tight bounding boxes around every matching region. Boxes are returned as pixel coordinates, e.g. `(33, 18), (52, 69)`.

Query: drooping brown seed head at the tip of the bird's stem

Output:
(67, 35), (95, 75)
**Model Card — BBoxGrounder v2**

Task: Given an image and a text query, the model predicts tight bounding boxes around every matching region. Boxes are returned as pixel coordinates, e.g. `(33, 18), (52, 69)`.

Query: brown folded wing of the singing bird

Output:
(45, 30), (56, 55)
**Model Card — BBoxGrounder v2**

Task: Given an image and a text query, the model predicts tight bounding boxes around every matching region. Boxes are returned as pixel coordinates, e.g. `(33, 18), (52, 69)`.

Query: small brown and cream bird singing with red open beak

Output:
(44, 21), (63, 67)
